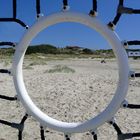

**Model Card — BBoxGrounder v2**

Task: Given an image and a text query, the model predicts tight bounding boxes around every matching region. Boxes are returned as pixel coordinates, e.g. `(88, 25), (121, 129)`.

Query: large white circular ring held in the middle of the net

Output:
(12, 12), (129, 133)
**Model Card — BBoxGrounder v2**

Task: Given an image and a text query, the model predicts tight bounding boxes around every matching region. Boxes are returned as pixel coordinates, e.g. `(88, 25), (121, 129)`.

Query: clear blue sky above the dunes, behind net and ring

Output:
(0, 0), (140, 49)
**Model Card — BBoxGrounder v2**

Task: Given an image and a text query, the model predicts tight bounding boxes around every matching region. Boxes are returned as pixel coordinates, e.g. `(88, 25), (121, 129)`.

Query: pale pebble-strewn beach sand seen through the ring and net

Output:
(0, 59), (140, 140)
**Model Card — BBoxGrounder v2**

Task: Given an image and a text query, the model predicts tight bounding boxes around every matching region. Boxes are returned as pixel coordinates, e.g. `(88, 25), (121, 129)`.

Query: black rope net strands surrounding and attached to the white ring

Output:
(0, 0), (140, 140)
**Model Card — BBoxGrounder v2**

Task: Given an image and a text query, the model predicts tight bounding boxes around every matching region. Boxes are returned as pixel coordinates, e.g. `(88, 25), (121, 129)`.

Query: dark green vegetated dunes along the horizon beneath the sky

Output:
(0, 44), (114, 58)
